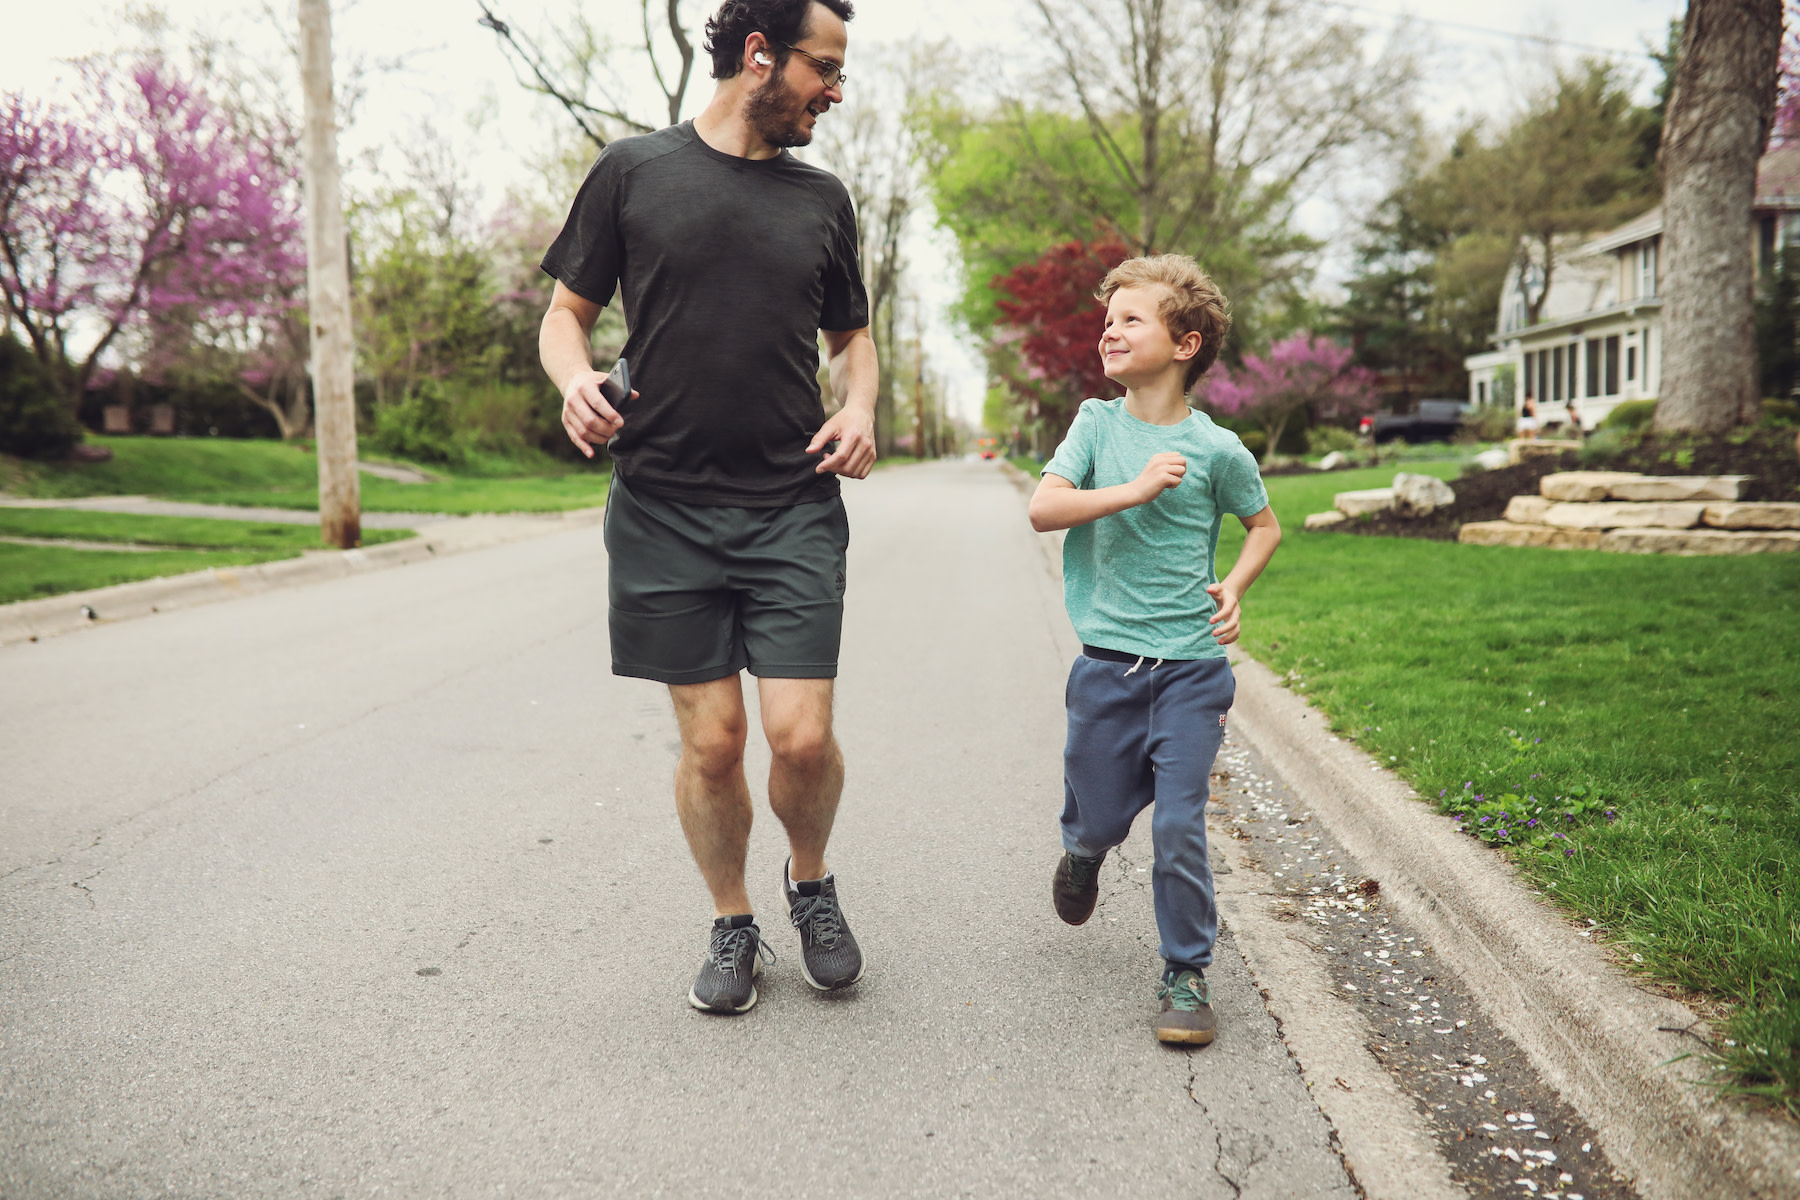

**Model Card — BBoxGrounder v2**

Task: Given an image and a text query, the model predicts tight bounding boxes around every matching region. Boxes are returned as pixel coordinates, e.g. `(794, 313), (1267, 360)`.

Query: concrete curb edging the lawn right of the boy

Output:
(1233, 653), (1800, 1200)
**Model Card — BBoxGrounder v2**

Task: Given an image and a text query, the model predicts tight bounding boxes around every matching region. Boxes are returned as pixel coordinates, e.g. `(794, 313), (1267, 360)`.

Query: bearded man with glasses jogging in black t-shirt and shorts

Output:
(538, 0), (877, 1013)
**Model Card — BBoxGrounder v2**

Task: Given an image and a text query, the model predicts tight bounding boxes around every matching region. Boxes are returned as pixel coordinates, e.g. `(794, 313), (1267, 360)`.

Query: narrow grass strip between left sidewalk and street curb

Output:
(0, 509), (414, 604)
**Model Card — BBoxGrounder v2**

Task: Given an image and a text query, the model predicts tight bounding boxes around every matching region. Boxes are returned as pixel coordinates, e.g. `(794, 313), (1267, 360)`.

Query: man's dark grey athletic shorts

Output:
(607, 473), (850, 684)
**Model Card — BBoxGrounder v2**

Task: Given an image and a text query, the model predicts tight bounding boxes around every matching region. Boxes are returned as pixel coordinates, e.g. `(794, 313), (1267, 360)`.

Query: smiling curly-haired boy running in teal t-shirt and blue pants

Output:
(1031, 254), (1282, 1045)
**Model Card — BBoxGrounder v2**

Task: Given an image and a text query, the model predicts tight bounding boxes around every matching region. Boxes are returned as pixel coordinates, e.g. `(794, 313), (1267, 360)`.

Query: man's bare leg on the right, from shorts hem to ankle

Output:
(758, 678), (844, 880)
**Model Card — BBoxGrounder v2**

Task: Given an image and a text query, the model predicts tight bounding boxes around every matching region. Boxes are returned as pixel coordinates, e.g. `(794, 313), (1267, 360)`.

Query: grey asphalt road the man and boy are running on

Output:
(0, 462), (1354, 1200)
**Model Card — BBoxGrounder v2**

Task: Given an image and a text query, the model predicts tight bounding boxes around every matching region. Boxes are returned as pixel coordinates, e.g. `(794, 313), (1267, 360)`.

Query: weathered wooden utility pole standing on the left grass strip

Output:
(299, 0), (362, 551)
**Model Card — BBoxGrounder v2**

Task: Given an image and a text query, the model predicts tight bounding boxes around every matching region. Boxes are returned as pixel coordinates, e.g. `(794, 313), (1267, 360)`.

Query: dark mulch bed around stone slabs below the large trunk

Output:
(1332, 430), (1800, 542)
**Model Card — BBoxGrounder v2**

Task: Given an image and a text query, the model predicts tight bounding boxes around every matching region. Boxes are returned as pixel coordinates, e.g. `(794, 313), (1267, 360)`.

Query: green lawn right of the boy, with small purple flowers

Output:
(1219, 464), (1800, 1115)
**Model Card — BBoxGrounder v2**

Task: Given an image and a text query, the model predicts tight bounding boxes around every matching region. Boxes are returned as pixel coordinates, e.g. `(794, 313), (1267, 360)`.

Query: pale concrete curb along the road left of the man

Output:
(0, 507), (607, 646)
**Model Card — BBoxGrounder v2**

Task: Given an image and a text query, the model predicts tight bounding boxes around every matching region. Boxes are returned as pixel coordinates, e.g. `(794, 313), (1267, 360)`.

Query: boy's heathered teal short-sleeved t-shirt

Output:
(1044, 399), (1269, 658)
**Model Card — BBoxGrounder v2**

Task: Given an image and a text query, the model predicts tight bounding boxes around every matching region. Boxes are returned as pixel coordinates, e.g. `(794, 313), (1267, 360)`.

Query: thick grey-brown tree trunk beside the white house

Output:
(1656, 0), (1782, 434)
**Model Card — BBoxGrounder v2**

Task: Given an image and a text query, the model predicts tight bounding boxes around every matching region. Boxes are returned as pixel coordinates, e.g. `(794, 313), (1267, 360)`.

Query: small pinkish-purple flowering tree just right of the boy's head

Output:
(1197, 333), (1379, 457)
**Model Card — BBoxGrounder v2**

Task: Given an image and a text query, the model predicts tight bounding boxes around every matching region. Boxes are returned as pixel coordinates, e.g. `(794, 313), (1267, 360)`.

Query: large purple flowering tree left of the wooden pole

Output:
(0, 59), (304, 422)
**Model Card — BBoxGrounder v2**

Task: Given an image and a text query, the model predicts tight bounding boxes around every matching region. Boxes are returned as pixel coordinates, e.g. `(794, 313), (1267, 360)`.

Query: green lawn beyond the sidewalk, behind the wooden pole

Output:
(0, 435), (610, 513)
